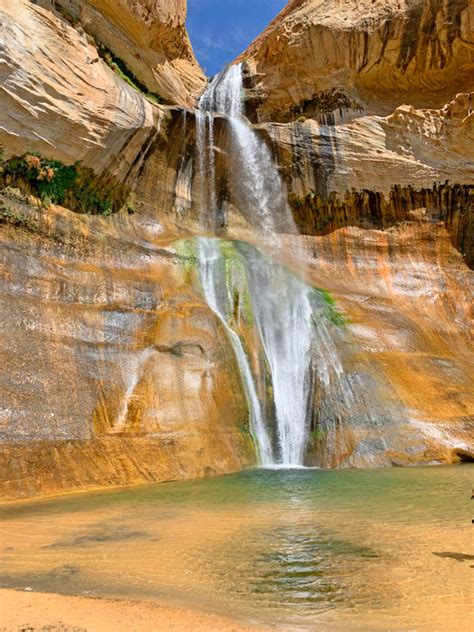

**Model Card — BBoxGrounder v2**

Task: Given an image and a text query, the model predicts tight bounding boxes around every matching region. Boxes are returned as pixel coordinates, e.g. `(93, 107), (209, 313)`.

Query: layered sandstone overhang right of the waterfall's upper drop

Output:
(231, 0), (474, 267)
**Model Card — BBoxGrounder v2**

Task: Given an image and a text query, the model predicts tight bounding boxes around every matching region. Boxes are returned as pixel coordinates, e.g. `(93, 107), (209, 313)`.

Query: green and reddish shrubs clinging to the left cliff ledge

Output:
(0, 152), (113, 216)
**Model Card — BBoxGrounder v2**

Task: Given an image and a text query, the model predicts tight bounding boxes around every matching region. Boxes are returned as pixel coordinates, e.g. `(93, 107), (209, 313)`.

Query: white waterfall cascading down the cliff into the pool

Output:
(196, 65), (322, 466)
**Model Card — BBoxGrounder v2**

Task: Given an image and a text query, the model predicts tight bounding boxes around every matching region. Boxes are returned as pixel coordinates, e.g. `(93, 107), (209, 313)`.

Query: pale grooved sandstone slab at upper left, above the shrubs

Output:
(0, 0), (157, 175)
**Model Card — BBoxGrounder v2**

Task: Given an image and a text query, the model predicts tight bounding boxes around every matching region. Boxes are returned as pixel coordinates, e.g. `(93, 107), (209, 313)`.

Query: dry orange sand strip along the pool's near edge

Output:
(0, 590), (264, 632)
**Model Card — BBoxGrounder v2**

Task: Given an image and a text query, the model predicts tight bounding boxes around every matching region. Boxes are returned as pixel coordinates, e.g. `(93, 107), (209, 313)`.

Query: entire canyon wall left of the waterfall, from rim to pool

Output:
(0, 0), (255, 498)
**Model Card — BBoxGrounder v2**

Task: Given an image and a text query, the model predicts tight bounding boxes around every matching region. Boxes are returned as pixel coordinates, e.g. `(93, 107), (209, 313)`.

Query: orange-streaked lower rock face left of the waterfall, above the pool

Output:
(0, 194), (255, 497)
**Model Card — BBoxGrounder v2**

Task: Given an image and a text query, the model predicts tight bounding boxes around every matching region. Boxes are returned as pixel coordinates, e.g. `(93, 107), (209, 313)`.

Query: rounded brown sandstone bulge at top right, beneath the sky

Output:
(242, 0), (474, 121)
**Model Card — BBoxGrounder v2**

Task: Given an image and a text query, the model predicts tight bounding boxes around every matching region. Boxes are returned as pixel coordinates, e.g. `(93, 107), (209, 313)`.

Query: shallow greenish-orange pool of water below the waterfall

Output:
(0, 465), (474, 630)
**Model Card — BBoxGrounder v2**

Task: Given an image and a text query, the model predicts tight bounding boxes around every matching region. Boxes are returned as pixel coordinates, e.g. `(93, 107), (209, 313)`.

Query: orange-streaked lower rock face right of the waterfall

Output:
(304, 225), (474, 467)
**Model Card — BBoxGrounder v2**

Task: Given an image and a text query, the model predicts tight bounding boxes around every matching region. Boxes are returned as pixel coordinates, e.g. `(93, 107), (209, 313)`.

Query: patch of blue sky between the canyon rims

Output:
(187, 0), (287, 76)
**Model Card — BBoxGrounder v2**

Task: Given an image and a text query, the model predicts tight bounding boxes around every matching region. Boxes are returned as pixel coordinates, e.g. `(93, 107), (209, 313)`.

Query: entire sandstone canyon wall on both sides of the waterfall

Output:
(0, 0), (474, 497)
